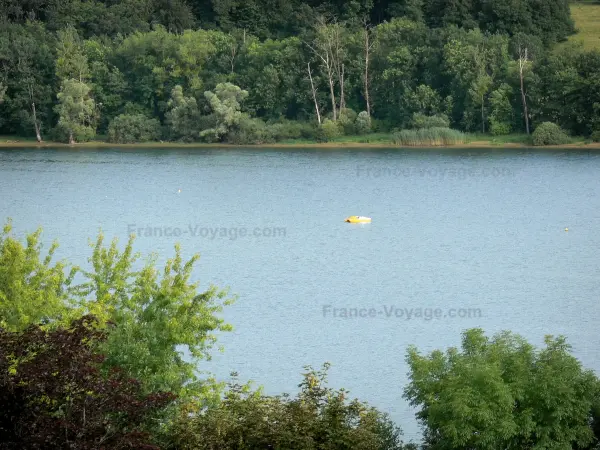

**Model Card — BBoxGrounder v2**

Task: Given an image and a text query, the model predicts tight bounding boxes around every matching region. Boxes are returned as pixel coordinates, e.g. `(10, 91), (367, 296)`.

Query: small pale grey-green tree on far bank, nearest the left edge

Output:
(56, 79), (96, 144)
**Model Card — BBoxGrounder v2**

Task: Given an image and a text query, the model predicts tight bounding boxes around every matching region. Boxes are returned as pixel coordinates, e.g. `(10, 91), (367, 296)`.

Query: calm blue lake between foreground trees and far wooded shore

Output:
(0, 148), (600, 440)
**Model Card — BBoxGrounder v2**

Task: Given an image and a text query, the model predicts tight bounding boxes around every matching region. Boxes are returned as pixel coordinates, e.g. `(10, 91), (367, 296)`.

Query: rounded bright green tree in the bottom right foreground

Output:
(405, 329), (598, 450)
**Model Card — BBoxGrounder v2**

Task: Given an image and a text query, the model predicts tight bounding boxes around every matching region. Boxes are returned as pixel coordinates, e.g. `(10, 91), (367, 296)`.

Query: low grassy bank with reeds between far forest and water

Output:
(0, 133), (600, 150)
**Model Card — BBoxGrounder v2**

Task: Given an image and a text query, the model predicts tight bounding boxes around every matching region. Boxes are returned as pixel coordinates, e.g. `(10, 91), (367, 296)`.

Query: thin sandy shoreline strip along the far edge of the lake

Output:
(0, 140), (600, 150)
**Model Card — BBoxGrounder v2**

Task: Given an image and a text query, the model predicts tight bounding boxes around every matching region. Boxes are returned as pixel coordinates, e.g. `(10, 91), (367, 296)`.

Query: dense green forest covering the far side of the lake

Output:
(0, 0), (600, 143)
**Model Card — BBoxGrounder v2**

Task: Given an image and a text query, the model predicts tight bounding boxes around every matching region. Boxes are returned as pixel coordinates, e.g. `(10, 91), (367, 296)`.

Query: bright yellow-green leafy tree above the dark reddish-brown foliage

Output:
(0, 223), (234, 401)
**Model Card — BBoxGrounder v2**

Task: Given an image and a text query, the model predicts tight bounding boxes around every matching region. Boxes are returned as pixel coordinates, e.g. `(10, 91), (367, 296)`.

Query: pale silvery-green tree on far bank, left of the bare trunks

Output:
(200, 83), (248, 140)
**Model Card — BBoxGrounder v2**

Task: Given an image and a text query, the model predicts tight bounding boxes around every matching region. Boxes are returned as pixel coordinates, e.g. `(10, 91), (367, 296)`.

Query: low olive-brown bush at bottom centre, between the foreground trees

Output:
(171, 364), (408, 450)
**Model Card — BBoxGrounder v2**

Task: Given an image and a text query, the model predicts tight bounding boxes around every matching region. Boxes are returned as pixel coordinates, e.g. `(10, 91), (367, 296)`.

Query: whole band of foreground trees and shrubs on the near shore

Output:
(0, 222), (600, 450)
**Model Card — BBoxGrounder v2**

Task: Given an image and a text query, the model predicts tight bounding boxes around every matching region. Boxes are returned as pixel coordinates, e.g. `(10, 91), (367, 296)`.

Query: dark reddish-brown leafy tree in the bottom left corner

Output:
(0, 316), (174, 450)
